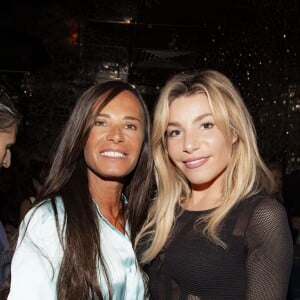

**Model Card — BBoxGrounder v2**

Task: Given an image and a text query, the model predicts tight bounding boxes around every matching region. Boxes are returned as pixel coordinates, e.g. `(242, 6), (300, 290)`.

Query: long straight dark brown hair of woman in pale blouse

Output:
(37, 81), (152, 300)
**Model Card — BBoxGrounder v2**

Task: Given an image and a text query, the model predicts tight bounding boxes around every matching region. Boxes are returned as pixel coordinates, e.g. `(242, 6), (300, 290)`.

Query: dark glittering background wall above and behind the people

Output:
(0, 0), (300, 173)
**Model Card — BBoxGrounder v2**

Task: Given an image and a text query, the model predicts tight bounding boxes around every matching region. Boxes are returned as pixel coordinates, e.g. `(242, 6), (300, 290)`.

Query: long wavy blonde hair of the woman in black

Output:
(136, 70), (272, 263)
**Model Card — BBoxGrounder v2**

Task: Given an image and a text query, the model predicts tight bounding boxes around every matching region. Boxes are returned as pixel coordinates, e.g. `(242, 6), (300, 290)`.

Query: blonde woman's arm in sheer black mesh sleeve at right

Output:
(246, 198), (293, 300)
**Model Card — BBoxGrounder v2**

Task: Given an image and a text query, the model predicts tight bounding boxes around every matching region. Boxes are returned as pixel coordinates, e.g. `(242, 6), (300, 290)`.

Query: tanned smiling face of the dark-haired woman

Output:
(84, 91), (144, 180)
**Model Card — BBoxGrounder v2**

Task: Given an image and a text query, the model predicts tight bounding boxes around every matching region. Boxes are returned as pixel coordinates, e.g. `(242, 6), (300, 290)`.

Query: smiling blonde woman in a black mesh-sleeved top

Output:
(136, 70), (292, 300)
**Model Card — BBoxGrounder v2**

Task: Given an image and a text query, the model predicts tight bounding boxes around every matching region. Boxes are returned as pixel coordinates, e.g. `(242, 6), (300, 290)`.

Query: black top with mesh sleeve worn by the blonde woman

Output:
(145, 194), (293, 300)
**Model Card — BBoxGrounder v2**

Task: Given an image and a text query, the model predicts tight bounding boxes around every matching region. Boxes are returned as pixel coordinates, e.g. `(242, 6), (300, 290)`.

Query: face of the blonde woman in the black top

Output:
(167, 93), (236, 189)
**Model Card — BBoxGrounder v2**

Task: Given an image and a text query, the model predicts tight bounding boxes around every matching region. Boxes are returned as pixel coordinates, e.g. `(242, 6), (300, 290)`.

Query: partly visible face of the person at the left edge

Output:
(0, 124), (17, 168)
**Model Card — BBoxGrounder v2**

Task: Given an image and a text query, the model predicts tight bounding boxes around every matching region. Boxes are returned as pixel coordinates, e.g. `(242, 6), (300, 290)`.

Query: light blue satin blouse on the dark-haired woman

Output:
(8, 197), (144, 300)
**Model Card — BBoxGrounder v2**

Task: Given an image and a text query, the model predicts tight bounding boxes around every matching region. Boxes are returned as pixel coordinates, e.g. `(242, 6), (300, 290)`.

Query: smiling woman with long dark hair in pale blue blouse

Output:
(8, 81), (153, 300)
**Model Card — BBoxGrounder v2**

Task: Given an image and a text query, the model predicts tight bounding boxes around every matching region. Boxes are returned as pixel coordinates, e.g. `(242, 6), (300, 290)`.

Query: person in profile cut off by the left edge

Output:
(0, 91), (20, 288)
